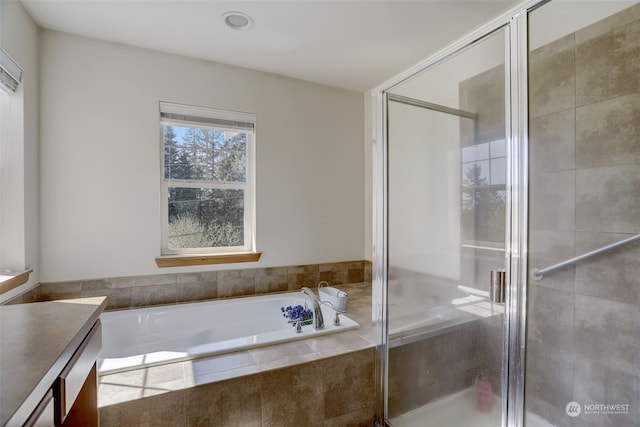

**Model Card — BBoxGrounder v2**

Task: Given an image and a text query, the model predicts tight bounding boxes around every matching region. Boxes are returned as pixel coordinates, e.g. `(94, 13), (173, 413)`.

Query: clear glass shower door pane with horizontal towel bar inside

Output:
(386, 28), (509, 427)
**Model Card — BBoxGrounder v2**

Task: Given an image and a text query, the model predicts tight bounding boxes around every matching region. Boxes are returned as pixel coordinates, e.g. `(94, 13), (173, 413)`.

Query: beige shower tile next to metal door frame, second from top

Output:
(529, 110), (576, 175)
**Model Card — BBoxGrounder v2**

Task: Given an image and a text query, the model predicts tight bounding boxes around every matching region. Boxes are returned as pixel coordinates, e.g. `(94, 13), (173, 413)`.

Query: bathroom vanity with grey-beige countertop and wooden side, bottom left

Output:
(0, 297), (106, 427)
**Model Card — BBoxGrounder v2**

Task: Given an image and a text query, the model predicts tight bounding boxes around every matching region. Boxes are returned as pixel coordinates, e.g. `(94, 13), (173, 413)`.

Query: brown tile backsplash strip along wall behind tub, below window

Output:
(10, 261), (371, 310)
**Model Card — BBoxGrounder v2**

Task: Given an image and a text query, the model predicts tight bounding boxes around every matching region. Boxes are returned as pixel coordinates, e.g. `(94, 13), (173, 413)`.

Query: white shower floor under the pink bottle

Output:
(389, 388), (554, 427)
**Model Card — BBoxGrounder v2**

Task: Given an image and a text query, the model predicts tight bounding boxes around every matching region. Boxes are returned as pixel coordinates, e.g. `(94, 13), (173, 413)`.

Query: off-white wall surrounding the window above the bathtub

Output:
(40, 30), (365, 281)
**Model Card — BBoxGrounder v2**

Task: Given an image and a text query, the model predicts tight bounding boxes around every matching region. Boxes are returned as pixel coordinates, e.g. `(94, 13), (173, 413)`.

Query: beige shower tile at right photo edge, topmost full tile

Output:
(576, 20), (640, 106)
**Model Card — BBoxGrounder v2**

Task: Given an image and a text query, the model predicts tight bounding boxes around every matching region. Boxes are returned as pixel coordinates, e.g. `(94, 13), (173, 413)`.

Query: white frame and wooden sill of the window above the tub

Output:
(156, 101), (256, 258)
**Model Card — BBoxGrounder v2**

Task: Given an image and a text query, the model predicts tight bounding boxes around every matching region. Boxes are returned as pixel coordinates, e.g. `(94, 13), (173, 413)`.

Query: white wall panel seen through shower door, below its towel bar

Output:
(388, 102), (461, 280)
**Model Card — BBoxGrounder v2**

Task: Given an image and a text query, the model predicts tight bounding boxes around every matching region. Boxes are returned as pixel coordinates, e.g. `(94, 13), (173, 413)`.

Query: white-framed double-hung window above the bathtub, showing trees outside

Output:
(160, 102), (255, 255)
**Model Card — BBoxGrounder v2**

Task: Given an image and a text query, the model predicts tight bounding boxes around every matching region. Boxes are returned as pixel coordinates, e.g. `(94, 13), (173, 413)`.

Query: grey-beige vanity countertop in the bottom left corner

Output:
(0, 297), (106, 426)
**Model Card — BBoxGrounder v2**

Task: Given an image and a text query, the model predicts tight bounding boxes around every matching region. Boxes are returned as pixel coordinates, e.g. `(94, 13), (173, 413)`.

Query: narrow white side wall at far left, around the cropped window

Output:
(0, 1), (39, 302)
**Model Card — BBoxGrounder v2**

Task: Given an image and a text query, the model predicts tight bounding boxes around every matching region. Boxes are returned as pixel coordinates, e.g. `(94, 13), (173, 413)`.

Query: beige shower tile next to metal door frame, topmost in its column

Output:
(529, 34), (576, 118)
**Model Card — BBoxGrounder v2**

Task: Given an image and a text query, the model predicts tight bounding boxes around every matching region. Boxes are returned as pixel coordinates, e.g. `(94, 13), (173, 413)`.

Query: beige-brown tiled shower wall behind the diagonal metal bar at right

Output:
(526, 5), (640, 427)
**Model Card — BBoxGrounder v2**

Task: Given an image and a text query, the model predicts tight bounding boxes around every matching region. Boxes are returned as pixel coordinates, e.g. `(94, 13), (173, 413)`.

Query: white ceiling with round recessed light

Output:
(21, 0), (515, 92)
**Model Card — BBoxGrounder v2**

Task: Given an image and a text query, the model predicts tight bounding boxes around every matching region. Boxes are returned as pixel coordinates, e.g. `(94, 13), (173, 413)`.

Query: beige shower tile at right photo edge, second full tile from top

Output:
(575, 93), (640, 169)
